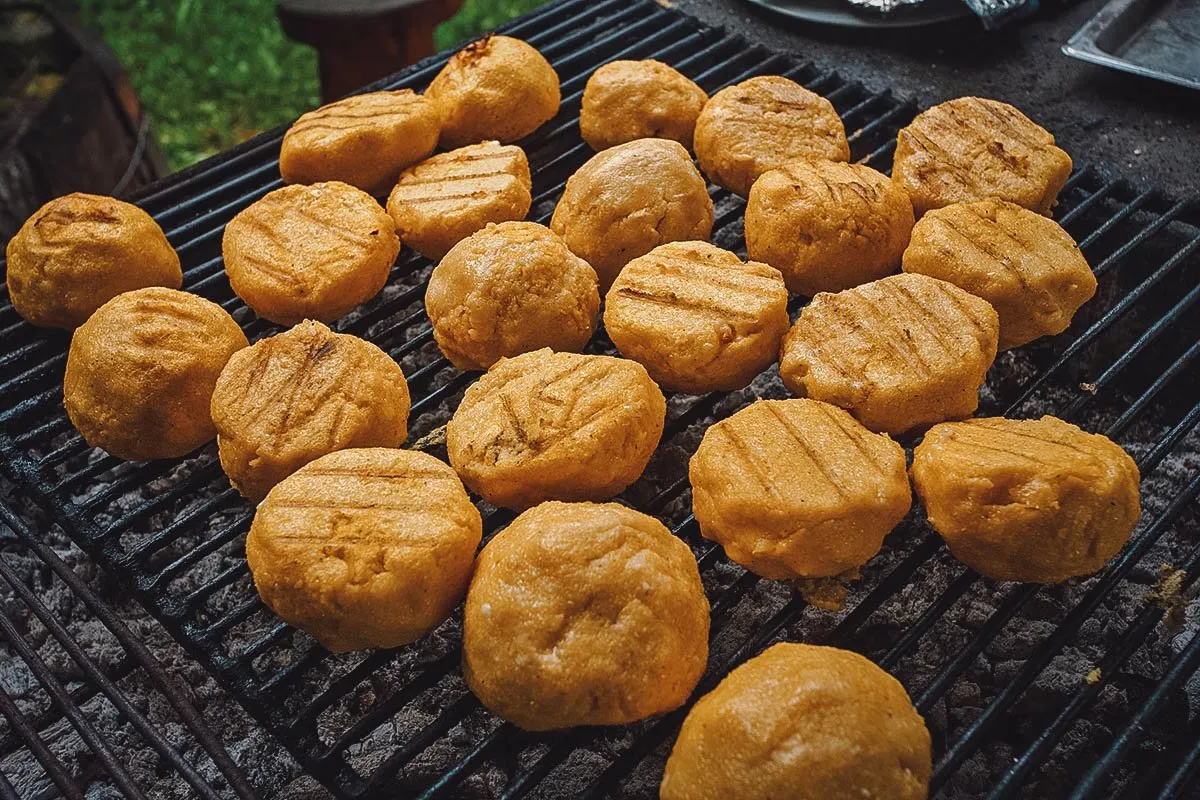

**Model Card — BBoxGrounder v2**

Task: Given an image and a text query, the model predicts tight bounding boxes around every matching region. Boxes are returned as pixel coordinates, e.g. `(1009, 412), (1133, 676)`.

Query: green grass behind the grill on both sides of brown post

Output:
(74, 0), (545, 169)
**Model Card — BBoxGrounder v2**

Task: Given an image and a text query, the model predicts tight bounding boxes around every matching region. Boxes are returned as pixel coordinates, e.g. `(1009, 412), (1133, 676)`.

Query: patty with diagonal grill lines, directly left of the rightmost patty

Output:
(688, 399), (912, 579)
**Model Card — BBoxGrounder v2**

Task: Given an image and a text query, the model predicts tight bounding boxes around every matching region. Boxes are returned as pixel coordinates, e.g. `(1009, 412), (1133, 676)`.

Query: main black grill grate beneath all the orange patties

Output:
(0, 0), (1200, 799)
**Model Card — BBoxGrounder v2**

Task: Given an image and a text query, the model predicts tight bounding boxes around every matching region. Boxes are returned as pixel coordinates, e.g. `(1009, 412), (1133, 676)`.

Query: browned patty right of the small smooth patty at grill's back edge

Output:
(695, 76), (850, 197)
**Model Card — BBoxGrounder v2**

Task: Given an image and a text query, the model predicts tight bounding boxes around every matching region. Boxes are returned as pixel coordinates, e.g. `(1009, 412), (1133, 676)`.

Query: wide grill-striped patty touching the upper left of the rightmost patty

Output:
(779, 275), (1000, 434)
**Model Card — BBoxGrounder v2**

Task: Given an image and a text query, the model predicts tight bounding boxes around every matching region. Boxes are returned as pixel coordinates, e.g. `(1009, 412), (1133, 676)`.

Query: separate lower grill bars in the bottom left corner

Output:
(0, 496), (254, 800)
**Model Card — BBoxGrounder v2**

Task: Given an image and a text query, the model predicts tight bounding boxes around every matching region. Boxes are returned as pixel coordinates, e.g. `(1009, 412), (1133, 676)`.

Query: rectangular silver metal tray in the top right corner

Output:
(1062, 0), (1200, 89)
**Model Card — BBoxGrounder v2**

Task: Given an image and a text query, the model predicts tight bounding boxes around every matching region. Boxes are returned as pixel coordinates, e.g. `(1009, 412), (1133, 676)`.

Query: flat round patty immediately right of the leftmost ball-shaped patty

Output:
(221, 181), (400, 325)
